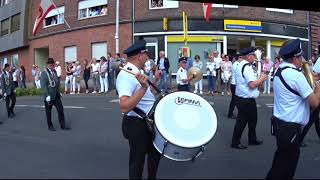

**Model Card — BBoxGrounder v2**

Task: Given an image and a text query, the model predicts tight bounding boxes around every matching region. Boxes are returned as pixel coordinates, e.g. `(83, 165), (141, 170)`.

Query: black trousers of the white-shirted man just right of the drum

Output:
(232, 96), (258, 145)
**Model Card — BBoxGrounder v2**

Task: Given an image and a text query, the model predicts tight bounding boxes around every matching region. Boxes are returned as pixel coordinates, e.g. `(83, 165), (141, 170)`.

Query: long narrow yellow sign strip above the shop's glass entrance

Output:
(167, 36), (223, 43)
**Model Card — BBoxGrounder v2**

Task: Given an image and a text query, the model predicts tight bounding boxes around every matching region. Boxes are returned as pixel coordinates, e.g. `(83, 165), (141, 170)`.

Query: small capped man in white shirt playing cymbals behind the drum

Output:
(176, 57), (193, 92)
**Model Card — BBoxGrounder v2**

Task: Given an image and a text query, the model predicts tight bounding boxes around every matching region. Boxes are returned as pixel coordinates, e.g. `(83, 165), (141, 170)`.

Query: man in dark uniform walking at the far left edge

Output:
(1, 64), (16, 118)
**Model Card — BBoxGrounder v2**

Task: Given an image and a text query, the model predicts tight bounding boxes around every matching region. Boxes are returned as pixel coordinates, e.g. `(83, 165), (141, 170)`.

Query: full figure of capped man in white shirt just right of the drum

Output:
(231, 47), (267, 149)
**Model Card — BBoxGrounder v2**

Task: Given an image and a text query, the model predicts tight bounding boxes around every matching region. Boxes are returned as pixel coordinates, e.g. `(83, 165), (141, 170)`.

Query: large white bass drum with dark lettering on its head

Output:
(153, 92), (217, 161)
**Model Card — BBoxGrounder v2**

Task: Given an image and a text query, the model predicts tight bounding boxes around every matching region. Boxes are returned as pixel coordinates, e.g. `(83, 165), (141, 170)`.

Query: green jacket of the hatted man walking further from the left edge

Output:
(40, 68), (61, 101)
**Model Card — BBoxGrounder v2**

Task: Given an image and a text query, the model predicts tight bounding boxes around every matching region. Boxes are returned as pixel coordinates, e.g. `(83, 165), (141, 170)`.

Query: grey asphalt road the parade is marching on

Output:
(0, 92), (320, 179)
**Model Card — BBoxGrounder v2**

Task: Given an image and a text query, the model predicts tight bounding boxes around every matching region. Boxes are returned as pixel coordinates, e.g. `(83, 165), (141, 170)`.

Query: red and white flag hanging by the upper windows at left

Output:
(32, 0), (55, 36)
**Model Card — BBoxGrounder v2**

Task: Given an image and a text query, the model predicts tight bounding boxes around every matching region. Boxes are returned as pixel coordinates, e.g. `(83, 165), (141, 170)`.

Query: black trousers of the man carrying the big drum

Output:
(122, 116), (161, 179)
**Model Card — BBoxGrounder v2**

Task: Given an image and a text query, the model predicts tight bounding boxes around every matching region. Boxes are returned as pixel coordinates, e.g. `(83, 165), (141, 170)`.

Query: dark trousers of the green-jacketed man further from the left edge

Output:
(44, 95), (66, 128)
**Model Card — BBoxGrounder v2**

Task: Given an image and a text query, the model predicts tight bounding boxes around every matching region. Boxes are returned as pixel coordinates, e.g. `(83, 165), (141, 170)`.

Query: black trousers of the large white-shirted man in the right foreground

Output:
(266, 118), (301, 179)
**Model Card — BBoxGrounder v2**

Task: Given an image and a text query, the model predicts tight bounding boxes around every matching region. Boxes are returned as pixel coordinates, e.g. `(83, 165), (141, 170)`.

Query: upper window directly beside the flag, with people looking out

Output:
(44, 6), (64, 27)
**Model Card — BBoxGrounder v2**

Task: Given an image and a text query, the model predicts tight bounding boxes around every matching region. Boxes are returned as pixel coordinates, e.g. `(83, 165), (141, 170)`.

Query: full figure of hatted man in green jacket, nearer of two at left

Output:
(40, 58), (70, 131)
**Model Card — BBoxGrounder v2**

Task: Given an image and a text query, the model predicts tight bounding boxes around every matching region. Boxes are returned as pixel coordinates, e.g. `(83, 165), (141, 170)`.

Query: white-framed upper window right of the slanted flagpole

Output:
(78, 0), (108, 20)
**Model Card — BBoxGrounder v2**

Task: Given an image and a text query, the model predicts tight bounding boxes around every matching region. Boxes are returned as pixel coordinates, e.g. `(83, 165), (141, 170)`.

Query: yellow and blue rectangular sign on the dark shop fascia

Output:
(224, 19), (262, 32)
